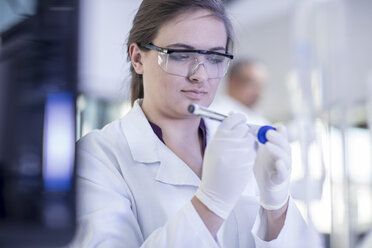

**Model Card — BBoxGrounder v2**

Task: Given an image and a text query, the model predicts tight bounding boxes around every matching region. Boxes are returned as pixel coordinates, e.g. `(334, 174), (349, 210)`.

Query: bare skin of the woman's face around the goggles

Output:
(142, 10), (227, 118)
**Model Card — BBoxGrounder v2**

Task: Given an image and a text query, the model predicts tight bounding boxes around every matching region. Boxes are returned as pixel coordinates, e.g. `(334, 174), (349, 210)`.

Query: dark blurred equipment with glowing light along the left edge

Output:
(0, 0), (78, 248)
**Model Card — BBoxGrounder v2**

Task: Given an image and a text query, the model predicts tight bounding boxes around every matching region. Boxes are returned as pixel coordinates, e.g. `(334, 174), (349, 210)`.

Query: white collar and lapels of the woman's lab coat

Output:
(122, 100), (221, 187)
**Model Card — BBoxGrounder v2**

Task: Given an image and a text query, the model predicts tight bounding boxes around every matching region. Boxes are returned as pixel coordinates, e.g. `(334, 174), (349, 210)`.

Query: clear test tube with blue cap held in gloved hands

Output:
(187, 104), (276, 144)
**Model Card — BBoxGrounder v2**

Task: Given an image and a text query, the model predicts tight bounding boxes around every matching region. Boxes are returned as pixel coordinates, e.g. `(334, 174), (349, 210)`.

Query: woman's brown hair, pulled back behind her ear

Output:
(127, 0), (233, 105)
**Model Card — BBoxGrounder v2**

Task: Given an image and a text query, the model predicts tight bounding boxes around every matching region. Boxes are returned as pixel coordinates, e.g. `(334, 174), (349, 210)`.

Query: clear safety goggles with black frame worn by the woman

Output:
(143, 43), (234, 79)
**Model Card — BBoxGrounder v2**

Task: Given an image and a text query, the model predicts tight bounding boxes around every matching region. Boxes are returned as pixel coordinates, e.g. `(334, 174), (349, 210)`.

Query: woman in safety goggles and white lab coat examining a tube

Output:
(72, 0), (320, 247)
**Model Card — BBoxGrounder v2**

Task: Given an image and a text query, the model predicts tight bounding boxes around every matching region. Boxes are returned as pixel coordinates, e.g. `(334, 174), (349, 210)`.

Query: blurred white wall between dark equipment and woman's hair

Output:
(79, 0), (140, 100)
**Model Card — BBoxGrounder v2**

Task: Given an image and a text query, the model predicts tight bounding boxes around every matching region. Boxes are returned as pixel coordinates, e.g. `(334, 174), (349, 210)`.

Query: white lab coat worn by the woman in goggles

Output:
(70, 101), (322, 248)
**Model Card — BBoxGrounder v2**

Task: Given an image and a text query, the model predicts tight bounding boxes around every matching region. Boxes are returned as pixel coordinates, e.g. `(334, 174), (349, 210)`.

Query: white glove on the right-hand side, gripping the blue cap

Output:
(253, 125), (292, 210)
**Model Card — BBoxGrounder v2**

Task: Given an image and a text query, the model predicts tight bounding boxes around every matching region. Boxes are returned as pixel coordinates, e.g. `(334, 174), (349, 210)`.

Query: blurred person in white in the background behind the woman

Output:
(210, 58), (269, 125)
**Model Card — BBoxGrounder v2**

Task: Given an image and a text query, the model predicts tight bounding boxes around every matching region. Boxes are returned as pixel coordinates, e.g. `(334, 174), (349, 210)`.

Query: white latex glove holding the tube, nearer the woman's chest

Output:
(195, 114), (255, 219)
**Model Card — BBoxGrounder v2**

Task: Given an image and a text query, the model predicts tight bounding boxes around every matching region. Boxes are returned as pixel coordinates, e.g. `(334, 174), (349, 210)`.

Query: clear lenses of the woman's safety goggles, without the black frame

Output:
(158, 52), (230, 78)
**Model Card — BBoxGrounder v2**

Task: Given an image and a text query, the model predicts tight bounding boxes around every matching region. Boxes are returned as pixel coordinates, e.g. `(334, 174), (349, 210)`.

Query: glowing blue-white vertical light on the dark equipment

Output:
(43, 92), (75, 191)
